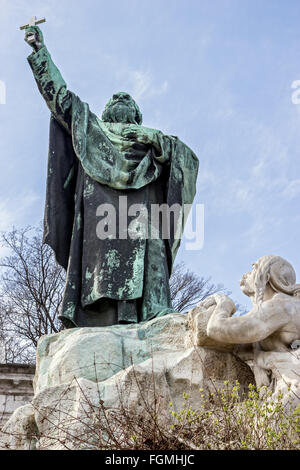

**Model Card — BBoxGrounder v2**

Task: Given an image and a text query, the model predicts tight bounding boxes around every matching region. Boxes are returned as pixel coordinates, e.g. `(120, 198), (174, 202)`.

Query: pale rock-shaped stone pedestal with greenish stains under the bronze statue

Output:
(0, 314), (254, 449)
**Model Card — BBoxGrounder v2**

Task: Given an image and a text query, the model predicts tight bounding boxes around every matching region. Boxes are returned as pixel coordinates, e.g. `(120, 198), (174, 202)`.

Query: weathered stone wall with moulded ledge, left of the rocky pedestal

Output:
(0, 364), (35, 428)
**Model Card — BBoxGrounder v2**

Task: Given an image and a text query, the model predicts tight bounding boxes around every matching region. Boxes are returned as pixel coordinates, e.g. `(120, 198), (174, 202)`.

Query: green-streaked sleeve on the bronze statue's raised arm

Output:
(27, 46), (72, 133)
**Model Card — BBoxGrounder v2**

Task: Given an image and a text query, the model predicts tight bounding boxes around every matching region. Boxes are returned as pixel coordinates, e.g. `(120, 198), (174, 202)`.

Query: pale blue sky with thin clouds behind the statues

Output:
(0, 0), (300, 305)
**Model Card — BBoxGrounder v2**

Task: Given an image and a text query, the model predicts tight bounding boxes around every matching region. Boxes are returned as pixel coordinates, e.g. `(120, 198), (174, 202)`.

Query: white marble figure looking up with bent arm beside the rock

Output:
(202, 255), (300, 404)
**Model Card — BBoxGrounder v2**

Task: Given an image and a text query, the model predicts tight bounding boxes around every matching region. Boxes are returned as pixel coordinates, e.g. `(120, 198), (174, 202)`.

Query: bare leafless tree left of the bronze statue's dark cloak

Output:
(0, 228), (64, 362)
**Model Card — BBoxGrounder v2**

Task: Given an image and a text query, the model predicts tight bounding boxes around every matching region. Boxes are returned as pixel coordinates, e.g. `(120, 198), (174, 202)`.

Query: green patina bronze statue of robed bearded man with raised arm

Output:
(25, 26), (198, 328)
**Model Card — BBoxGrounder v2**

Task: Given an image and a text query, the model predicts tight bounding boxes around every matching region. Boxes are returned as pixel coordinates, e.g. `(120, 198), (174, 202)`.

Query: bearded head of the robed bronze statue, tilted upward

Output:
(102, 92), (142, 124)
